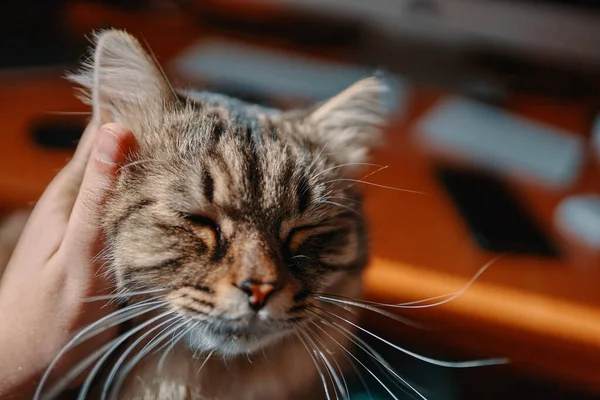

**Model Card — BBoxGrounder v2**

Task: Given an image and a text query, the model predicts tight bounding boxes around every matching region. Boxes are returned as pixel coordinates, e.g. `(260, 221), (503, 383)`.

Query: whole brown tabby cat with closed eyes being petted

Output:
(15, 30), (392, 400)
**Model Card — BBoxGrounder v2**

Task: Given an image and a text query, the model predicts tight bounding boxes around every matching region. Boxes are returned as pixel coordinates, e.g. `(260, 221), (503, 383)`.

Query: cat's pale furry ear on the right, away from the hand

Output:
(304, 76), (396, 171)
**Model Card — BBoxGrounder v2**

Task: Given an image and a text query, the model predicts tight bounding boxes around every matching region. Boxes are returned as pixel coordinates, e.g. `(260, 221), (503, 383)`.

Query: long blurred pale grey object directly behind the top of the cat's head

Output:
(170, 40), (406, 110)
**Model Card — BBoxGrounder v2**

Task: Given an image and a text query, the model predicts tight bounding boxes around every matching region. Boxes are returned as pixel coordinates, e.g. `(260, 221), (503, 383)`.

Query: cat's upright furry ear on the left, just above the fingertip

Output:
(69, 30), (177, 127)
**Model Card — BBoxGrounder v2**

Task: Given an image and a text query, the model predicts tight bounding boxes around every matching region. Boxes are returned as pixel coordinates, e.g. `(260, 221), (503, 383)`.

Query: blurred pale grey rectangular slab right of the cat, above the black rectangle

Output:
(416, 98), (584, 189)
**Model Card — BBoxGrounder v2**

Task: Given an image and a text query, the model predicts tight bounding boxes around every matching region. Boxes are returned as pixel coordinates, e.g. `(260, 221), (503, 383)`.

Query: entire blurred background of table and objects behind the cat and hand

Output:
(0, 0), (600, 400)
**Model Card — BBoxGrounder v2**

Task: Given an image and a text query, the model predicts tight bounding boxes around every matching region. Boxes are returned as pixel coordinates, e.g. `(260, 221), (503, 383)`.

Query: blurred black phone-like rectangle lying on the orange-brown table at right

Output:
(437, 167), (558, 257)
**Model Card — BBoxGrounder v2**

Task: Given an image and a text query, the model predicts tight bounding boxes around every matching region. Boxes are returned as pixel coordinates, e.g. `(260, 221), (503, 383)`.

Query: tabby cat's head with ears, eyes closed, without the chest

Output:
(73, 31), (389, 354)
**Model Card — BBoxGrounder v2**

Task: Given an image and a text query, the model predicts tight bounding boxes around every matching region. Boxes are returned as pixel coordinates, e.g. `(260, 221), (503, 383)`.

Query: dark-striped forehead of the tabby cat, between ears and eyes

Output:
(136, 95), (316, 223)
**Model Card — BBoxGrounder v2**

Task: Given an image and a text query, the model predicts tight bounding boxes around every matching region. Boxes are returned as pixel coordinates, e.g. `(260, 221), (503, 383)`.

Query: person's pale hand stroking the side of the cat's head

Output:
(0, 124), (135, 399)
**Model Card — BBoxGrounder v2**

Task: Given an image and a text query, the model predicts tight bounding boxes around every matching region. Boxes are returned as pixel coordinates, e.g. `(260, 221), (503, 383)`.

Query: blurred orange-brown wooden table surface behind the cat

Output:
(0, 3), (600, 393)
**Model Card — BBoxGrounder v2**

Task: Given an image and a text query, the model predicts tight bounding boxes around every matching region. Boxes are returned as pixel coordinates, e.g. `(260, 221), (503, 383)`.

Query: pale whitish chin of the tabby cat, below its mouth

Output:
(186, 327), (291, 357)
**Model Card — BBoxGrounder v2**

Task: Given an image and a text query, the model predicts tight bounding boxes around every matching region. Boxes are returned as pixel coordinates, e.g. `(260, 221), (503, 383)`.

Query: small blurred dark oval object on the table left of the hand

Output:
(30, 114), (89, 149)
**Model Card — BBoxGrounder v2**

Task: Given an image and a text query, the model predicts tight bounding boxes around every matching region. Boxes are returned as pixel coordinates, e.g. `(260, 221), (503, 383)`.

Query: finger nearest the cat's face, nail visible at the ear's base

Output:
(61, 124), (135, 260)
